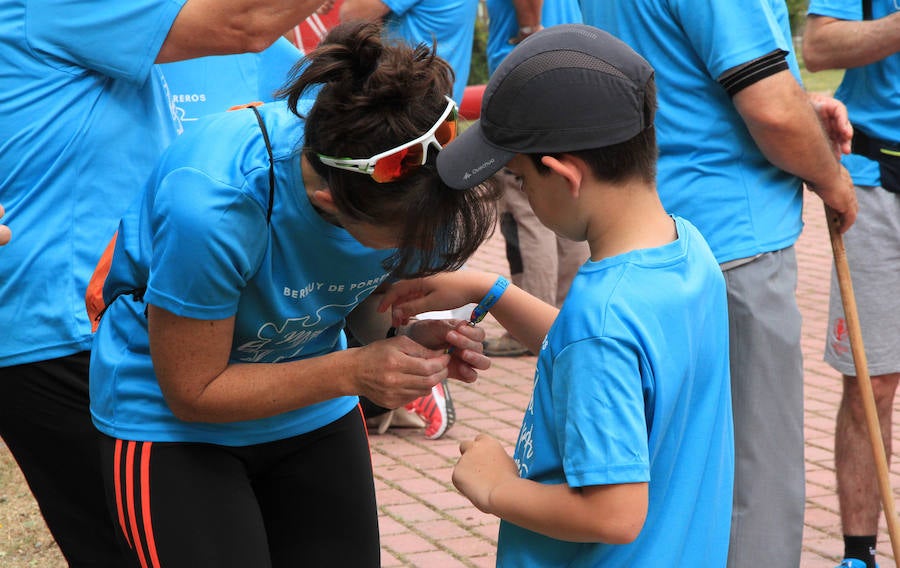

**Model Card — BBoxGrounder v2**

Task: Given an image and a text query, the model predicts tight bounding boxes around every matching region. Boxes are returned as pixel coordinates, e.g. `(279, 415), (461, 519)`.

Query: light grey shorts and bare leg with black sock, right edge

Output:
(825, 187), (900, 568)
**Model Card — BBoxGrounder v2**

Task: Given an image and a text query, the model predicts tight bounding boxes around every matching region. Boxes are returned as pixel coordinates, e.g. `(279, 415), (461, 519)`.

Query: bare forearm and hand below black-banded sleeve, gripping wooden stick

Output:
(733, 70), (858, 232)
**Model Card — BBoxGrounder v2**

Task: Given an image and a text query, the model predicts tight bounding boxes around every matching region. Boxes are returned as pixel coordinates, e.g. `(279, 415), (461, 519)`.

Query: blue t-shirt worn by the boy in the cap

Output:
(497, 218), (734, 568)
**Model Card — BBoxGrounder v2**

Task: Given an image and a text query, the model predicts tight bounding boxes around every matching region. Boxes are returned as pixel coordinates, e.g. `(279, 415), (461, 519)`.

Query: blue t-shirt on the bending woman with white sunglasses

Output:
(91, 101), (393, 446)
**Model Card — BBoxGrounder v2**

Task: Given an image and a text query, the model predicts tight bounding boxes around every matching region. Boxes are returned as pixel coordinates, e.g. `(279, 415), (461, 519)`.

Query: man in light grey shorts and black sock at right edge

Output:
(803, 0), (900, 568)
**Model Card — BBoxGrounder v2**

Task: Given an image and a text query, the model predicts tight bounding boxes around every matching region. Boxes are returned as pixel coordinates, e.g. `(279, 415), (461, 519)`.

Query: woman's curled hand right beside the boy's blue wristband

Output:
(405, 319), (491, 383)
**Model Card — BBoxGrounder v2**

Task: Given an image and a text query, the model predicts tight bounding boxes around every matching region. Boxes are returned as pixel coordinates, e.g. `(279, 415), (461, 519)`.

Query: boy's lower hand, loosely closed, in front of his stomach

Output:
(453, 434), (519, 514)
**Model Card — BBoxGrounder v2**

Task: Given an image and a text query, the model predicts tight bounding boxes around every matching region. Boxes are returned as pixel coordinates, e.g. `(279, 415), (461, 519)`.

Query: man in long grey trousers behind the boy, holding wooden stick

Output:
(582, 0), (856, 568)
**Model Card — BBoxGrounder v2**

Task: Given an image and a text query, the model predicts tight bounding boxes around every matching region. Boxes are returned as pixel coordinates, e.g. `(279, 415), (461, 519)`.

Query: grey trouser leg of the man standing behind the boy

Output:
(725, 247), (806, 568)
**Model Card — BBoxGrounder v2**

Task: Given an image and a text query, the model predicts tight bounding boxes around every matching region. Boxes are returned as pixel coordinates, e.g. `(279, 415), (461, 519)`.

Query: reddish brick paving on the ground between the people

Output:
(371, 194), (900, 568)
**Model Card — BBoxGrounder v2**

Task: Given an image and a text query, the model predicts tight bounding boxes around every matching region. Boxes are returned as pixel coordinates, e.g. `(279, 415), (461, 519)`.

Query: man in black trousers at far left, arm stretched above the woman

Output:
(0, 0), (328, 568)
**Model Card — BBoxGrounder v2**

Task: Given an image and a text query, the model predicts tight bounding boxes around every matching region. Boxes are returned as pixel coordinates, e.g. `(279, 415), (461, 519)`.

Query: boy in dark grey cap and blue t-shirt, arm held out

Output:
(381, 24), (734, 568)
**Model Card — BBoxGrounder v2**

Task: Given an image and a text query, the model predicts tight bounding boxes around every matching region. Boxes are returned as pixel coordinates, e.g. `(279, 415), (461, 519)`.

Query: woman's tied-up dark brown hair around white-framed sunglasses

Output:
(279, 22), (499, 278)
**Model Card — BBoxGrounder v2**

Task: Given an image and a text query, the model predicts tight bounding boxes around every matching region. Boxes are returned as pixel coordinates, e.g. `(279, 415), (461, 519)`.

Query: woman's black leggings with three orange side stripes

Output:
(101, 409), (380, 568)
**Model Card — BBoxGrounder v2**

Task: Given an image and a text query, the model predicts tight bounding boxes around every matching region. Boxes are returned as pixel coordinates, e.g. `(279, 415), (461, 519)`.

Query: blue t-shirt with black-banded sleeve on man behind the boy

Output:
(582, 0), (803, 263)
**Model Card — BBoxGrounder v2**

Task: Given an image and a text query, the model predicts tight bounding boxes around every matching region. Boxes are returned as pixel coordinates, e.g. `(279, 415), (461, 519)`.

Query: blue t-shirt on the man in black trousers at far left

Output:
(0, 0), (184, 367)
